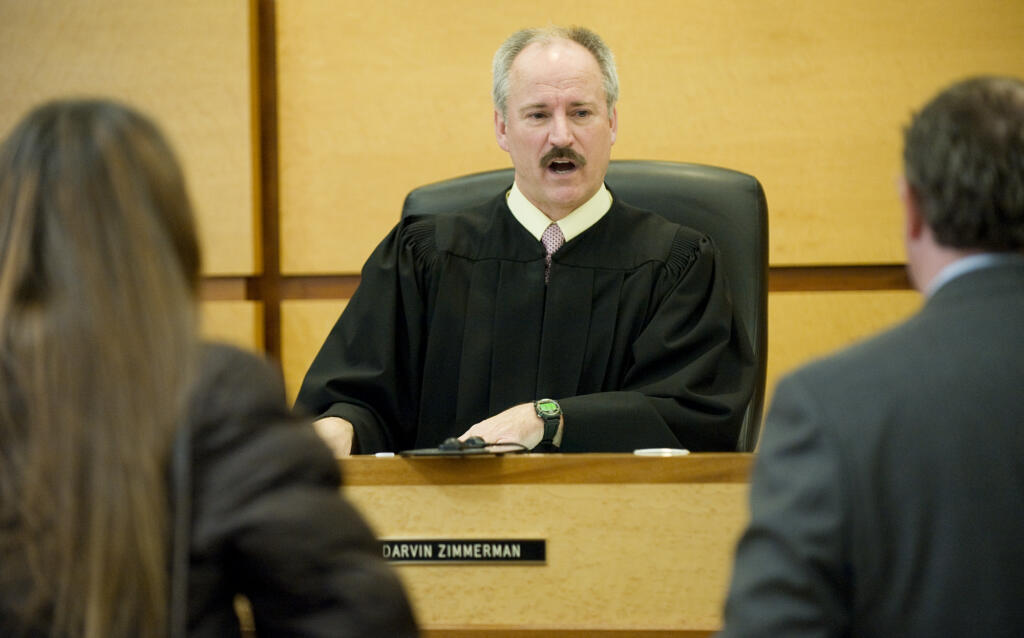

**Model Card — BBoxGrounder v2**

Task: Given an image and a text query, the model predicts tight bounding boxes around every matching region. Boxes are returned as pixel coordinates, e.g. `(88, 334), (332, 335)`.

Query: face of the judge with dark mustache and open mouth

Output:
(495, 40), (617, 220)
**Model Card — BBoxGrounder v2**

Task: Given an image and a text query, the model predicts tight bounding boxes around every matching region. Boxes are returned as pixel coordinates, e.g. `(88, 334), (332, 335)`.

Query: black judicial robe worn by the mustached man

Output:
(297, 193), (754, 453)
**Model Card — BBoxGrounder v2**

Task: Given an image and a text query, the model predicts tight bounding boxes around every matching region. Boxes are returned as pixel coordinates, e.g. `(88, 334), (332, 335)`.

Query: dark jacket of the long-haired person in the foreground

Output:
(182, 346), (416, 638)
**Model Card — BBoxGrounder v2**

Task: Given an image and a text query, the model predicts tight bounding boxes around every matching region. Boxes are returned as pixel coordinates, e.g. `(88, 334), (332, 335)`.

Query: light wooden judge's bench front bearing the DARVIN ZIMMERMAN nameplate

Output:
(341, 454), (753, 638)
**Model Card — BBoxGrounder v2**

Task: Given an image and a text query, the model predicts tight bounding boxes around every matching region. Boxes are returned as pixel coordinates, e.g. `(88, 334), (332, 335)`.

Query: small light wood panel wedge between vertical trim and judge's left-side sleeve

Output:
(281, 299), (348, 401)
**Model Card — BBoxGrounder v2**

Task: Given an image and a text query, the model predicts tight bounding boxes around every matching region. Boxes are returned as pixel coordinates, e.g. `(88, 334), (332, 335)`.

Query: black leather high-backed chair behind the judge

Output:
(401, 160), (768, 452)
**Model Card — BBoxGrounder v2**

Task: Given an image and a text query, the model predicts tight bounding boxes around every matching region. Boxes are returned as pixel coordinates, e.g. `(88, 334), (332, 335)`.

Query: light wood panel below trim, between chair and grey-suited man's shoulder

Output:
(765, 291), (923, 402)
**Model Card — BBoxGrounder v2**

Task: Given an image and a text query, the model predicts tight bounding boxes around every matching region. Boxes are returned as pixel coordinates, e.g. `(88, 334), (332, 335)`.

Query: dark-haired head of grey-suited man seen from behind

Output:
(903, 77), (1024, 288)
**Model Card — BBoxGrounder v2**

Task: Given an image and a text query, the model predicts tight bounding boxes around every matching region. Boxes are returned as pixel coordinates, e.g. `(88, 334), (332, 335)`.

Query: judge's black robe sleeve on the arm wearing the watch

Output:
(556, 232), (755, 452)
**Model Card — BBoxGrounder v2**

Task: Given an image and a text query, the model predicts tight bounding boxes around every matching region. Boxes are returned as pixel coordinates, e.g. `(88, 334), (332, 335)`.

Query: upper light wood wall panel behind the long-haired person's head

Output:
(0, 0), (258, 274)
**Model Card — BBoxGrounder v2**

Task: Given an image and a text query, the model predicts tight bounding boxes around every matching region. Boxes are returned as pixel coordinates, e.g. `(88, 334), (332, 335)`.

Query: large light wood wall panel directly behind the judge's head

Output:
(278, 0), (1024, 273)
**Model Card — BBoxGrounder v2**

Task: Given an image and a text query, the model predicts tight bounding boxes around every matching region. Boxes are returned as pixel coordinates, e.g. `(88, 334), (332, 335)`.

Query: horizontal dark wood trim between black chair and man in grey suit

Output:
(768, 263), (911, 293)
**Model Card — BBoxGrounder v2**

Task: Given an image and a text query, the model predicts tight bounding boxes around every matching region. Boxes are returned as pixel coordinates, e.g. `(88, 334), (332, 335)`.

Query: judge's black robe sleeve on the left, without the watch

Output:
(296, 219), (436, 454)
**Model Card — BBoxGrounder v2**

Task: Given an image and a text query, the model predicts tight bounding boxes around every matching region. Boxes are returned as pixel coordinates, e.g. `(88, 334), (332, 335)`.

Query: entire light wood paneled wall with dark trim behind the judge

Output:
(0, 0), (1024, 411)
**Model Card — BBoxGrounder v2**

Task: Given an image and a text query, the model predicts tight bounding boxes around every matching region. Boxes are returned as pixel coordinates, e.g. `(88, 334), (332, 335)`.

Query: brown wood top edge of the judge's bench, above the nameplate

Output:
(339, 454), (754, 487)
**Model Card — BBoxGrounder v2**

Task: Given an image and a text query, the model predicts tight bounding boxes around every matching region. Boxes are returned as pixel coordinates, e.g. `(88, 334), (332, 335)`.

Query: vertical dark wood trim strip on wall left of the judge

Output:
(250, 0), (281, 360)
